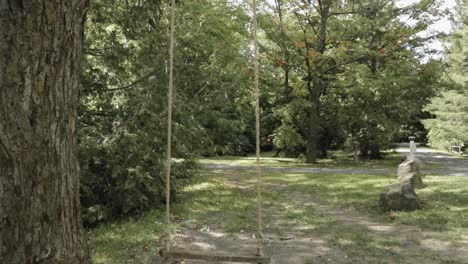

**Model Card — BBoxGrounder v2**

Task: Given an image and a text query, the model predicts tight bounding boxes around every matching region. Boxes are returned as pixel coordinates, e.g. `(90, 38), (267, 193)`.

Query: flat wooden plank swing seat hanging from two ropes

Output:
(159, 249), (271, 264)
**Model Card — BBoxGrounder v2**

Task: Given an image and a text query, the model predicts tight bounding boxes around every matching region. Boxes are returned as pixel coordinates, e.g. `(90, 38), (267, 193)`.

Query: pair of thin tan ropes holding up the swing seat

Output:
(165, 0), (263, 256)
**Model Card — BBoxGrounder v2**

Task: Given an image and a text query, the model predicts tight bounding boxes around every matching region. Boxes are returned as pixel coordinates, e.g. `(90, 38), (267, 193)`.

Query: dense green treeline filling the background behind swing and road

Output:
(80, 0), (466, 224)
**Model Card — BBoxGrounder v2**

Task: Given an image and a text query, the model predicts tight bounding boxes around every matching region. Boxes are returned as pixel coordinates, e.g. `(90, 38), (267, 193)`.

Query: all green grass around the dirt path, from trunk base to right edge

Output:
(88, 170), (468, 264)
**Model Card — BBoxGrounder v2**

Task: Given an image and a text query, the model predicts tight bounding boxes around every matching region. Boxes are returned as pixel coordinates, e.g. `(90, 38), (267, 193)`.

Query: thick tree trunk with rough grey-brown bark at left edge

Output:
(0, 0), (90, 264)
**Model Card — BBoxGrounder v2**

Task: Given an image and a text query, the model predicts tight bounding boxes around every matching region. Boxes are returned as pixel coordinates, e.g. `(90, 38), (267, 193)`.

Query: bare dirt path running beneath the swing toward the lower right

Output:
(155, 172), (468, 264)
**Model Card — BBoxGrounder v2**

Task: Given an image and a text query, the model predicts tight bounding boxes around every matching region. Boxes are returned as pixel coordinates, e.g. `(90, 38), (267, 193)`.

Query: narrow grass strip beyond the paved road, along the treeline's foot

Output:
(200, 151), (444, 169)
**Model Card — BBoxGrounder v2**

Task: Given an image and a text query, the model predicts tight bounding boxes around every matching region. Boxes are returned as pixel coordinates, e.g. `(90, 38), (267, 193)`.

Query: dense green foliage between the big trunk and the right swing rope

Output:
(80, 0), (253, 222)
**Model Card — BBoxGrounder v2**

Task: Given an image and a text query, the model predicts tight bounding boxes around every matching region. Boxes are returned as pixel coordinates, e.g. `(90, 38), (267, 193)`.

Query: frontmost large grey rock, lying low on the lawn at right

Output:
(379, 181), (422, 211)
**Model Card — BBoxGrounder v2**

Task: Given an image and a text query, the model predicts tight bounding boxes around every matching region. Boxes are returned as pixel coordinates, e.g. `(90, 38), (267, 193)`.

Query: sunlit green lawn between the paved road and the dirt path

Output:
(185, 170), (468, 232)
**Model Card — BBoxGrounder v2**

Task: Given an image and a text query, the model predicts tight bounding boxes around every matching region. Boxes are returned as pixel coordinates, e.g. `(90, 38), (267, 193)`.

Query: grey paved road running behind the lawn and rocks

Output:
(204, 144), (468, 177)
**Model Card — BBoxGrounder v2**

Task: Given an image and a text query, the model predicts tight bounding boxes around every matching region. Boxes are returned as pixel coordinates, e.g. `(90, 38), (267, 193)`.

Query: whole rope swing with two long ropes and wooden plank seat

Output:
(160, 0), (271, 263)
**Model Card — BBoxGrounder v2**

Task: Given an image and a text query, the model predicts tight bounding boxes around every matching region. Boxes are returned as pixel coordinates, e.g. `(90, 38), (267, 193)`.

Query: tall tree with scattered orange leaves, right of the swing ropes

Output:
(264, 0), (442, 163)
